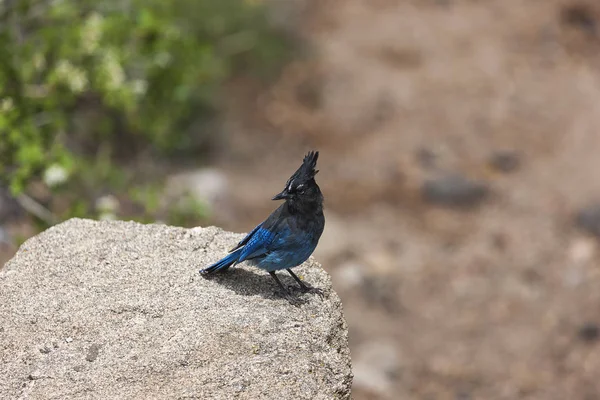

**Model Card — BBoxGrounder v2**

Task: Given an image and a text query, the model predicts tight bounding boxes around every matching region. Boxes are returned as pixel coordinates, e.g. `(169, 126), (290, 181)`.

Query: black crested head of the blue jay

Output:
(273, 151), (322, 201)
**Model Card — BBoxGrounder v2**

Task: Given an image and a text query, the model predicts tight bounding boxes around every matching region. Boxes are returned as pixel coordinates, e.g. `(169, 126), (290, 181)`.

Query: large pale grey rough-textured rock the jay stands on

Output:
(0, 219), (352, 399)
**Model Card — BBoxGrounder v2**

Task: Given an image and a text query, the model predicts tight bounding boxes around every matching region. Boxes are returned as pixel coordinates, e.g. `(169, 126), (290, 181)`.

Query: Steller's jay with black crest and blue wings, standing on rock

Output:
(200, 151), (325, 303)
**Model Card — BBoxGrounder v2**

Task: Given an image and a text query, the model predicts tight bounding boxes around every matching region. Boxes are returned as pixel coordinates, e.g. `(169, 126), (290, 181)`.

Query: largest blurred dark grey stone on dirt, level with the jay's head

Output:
(422, 174), (490, 208)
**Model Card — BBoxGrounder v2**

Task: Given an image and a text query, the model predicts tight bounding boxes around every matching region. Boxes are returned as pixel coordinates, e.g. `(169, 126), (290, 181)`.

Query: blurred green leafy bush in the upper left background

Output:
(0, 0), (288, 194)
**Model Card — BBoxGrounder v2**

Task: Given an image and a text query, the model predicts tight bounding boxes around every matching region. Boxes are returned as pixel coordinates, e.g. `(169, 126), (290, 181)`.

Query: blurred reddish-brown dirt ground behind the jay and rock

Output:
(219, 0), (600, 400)
